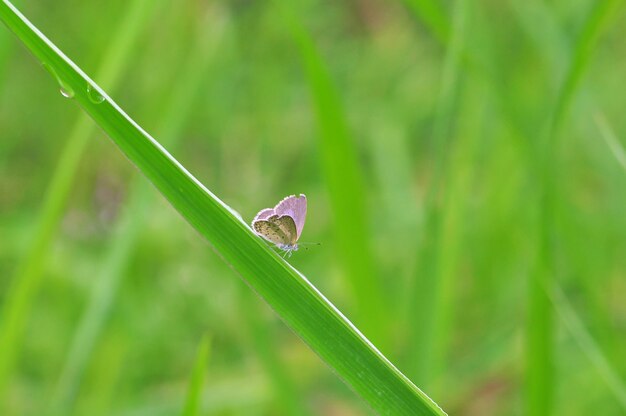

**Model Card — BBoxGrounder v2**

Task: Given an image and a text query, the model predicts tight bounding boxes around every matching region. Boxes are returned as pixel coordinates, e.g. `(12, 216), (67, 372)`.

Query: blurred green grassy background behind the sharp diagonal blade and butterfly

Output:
(0, 0), (626, 415)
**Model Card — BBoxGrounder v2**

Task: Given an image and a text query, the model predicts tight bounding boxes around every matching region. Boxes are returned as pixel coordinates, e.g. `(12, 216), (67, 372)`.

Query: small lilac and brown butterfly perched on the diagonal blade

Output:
(252, 194), (306, 256)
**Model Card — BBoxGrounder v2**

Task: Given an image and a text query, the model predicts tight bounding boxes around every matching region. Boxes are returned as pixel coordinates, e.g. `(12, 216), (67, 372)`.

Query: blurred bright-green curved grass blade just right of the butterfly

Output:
(276, 3), (387, 343)
